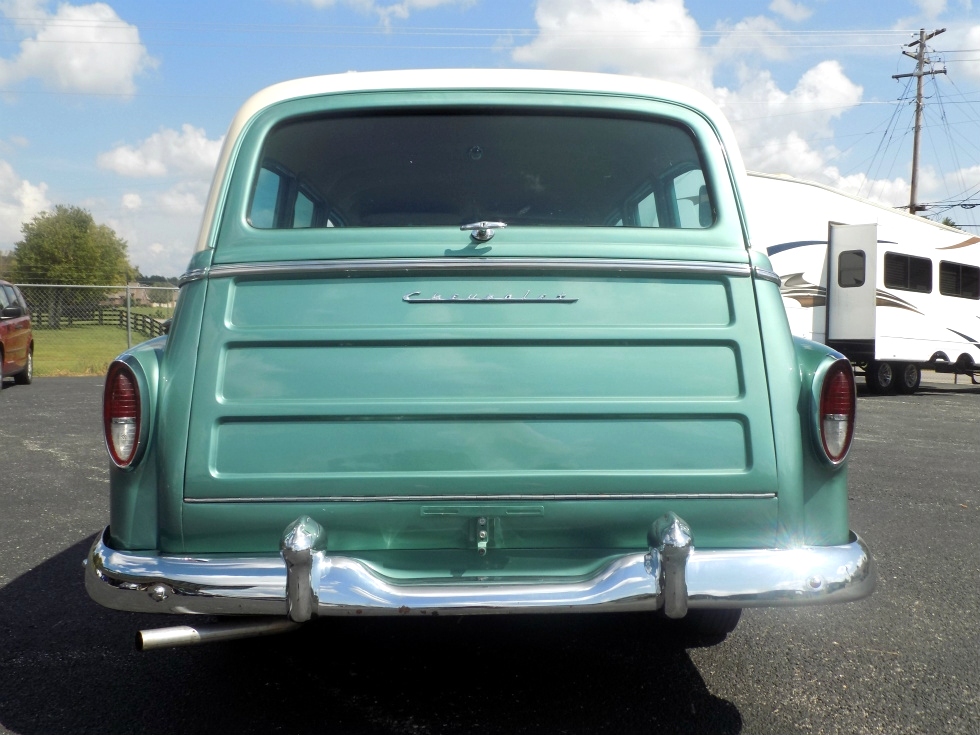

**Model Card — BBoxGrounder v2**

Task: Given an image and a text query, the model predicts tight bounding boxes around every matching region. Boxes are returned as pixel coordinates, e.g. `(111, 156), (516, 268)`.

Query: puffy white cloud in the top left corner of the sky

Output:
(0, 0), (156, 96)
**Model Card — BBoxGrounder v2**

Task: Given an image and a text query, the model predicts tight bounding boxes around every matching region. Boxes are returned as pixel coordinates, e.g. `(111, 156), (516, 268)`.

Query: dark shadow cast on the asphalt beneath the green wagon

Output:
(0, 539), (742, 735)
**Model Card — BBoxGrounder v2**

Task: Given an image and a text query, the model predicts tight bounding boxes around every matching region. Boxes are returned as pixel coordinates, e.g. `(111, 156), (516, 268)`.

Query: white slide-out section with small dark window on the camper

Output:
(827, 223), (878, 362)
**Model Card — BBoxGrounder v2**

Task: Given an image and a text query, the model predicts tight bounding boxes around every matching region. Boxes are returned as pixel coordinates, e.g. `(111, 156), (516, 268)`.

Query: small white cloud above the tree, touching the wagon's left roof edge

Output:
(98, 124), (223, 179)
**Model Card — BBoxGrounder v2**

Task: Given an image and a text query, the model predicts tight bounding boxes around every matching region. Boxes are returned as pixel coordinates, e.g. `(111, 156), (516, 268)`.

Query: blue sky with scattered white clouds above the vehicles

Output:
(0, 0), (980, 276)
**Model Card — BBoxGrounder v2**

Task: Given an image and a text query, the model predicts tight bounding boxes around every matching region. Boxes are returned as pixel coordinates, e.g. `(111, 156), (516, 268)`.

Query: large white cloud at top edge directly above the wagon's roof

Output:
(512, 0), (711, 91)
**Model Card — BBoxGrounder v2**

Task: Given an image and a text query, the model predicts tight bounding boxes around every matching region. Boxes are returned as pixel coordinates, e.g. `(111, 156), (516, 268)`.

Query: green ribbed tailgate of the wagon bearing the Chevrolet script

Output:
(183, 259), (776, 550)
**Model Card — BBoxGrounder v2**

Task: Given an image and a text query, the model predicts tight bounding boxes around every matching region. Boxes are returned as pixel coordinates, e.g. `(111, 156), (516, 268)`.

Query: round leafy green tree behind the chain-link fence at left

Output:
(10, 204), (136, 329)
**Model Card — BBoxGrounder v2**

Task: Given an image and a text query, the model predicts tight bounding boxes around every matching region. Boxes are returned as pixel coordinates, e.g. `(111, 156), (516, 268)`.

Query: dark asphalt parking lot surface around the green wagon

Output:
(0, 376), (980, 735)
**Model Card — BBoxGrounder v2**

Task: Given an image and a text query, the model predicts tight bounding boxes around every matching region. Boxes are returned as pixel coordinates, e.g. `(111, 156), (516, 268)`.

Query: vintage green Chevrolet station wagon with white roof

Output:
(85, 70), (875, 648)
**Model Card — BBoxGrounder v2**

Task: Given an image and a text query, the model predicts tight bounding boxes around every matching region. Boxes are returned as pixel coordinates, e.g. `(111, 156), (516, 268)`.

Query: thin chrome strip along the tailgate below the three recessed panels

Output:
(184, 493), (776, 504)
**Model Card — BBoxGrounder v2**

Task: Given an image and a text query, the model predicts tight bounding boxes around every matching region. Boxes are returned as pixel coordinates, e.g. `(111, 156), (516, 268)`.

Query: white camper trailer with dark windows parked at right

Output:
(745, 173), (980, 393)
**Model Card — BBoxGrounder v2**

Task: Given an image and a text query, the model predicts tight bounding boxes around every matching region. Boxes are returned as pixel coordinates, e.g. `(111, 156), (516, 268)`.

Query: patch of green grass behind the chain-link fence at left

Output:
(34, 326), (140, 377)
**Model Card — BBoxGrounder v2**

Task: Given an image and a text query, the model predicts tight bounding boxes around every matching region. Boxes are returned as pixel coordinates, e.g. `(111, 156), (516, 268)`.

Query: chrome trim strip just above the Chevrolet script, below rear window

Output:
(197, 258), (752, 282)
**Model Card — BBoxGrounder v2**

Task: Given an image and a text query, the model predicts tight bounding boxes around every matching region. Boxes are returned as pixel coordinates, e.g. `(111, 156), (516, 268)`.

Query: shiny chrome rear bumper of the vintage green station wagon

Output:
(85, 514), (875, 622)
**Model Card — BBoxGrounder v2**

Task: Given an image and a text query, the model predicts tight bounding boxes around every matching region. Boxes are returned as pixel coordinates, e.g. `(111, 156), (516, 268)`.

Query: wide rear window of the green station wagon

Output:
(249, 110), (715, 229)
